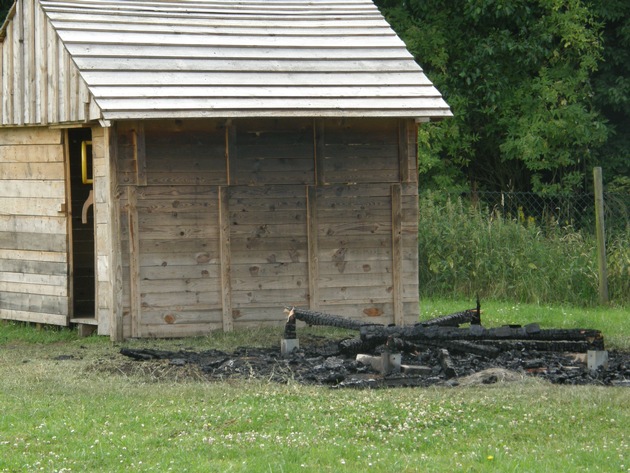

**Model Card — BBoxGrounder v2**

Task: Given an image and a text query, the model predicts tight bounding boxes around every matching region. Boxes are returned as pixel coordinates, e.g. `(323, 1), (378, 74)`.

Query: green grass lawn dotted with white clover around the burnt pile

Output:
(0, 301), (630, 473)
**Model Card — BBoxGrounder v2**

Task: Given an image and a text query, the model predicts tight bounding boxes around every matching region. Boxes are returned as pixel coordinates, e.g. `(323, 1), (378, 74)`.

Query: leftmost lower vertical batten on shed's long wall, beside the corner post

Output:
(127, 186), (142, 337)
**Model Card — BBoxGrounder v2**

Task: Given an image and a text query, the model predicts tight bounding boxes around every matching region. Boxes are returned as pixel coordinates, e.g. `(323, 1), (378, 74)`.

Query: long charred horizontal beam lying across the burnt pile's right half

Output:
(360, 324), (604, 350)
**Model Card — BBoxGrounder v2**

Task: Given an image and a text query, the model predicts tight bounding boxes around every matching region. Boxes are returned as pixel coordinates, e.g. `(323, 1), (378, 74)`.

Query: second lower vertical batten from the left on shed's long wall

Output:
(219, 187), (234, 332)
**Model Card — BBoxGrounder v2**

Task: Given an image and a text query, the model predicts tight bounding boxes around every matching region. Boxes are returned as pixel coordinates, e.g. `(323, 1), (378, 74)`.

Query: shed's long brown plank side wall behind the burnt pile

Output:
(113, 119), (418, 336)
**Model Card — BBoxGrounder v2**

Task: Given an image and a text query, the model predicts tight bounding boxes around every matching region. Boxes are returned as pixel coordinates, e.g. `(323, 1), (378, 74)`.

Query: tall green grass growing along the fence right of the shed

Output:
(418, 193), (630, 306)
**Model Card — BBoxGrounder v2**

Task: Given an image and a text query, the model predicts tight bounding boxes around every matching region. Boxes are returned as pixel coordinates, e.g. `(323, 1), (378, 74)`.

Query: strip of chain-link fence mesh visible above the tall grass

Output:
(446, 191), (630, 235)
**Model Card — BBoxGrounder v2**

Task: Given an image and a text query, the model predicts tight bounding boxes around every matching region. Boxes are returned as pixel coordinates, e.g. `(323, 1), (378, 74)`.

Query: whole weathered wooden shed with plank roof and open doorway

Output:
(0, 0), (451, 340)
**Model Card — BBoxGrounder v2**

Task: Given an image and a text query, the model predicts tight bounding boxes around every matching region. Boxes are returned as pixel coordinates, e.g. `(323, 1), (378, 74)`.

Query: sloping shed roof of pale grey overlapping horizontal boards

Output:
(2, 0), (451, 120)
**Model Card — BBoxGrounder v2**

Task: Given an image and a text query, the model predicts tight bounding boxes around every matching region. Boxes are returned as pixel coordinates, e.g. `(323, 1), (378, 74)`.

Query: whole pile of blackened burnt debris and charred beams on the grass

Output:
(121, 302), (630, 388)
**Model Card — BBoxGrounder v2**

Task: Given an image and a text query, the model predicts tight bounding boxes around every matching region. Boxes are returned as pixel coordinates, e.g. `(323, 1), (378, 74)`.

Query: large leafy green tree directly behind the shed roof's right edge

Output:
(377, 0), (608, 192)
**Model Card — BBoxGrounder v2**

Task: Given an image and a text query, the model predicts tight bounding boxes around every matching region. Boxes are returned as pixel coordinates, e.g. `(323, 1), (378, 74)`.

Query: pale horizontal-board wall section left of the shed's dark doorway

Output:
(0, 128), (69, 325)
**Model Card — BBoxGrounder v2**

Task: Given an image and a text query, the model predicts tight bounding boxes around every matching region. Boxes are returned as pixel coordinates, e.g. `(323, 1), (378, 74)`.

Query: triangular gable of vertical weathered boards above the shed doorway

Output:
(0, 0), (94, 125)
